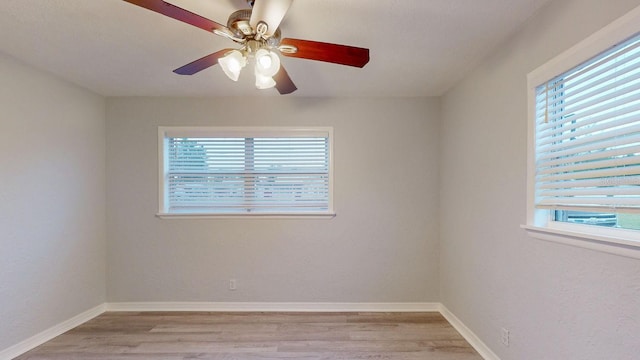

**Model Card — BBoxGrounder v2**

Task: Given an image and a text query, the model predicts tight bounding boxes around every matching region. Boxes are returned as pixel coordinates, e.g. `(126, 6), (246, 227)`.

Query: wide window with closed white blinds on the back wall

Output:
(159, 127), (333, 216)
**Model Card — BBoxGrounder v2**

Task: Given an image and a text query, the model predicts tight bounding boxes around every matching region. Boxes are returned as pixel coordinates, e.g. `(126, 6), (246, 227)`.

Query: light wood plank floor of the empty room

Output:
(16, 312), (482, 360)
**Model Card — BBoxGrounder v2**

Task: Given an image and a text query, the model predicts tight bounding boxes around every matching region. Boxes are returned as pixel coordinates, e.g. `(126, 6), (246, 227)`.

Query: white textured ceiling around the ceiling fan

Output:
(0, 0), (548, 97)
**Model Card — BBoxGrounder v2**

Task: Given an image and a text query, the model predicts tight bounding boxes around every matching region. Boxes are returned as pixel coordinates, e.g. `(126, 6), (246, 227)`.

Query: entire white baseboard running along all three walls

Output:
(0, 302), (500, 360)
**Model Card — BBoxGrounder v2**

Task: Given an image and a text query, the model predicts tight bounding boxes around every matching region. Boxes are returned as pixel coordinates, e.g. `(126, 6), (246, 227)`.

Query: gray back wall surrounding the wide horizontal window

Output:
(107, 97), (439, 302)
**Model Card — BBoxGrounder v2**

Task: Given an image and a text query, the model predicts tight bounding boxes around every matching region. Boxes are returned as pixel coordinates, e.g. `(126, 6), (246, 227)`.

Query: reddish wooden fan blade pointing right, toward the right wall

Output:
(280, 39), (369, 67)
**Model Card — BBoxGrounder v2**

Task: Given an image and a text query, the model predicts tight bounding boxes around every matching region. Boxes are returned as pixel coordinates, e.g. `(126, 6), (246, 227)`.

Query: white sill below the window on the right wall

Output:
(520, 225), (640, 259)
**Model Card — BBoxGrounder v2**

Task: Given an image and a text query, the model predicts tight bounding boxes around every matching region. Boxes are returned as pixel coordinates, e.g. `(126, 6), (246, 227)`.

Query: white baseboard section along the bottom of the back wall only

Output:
(107, 302), (440, 312)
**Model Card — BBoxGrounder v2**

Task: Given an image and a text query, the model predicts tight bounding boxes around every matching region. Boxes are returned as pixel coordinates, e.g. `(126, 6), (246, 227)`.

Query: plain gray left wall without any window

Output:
(0, 53), (106, 350)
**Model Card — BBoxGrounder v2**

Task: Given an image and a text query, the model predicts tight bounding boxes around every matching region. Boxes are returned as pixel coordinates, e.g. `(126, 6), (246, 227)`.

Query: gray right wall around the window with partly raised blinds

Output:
(440, 0), (640, 360)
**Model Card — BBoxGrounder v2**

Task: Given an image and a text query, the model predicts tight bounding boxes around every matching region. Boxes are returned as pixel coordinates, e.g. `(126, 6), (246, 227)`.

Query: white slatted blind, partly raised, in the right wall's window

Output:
(535, 35), (640, 212)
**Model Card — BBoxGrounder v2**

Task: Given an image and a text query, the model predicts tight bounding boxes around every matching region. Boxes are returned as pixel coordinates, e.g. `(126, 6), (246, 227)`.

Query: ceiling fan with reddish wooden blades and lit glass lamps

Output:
(124, 0), (369, 95)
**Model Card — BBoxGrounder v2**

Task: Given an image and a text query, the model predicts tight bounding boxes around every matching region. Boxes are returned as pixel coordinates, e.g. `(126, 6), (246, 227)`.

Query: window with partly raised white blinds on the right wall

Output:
(528, 8), (640, 256)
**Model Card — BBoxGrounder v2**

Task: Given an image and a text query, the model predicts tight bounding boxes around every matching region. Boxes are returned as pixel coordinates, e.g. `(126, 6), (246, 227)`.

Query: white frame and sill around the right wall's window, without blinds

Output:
(522, 7), (640, 259)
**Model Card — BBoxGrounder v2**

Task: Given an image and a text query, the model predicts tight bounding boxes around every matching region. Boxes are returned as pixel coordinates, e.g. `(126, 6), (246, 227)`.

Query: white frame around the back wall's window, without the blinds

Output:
(156, 126), (336, 219)
